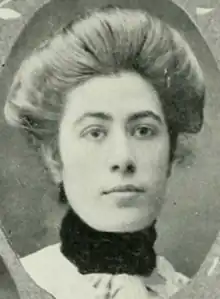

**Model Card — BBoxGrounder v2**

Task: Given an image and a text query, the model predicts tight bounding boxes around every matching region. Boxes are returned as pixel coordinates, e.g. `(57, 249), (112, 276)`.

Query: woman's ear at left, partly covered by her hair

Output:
(41, 145), (62, 185)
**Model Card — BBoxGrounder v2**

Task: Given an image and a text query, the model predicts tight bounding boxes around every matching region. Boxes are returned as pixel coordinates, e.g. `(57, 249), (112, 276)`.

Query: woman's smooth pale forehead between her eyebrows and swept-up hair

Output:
(63, 73), (163, 120)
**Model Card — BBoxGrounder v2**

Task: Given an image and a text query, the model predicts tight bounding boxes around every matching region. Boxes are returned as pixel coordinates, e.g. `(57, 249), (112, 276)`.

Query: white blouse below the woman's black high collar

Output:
(21, 244), (189, 299)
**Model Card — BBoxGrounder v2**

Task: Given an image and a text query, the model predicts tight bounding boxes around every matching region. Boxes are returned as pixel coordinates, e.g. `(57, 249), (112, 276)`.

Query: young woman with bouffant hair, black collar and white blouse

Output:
(5, 7), (205, 299)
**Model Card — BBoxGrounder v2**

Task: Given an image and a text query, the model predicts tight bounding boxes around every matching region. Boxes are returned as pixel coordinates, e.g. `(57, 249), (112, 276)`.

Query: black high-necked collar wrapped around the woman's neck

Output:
(60, 209), (157, 276)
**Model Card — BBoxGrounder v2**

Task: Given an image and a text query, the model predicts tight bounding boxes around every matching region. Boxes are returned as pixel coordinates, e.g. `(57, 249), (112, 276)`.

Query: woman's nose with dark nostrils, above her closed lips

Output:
(110, 138), (137, 174)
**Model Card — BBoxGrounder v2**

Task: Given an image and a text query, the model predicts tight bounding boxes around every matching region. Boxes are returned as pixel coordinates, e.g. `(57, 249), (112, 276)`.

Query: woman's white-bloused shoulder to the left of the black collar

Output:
(20, 244), (96, 299)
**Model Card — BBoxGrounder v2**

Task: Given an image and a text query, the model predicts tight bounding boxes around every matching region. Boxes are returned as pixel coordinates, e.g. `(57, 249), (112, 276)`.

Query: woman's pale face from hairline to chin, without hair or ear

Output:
(59, 73), (169, 232)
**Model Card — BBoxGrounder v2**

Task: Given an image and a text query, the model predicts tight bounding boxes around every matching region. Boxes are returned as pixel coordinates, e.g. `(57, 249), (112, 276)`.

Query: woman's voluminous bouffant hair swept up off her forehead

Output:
(4, 8), (205, 181)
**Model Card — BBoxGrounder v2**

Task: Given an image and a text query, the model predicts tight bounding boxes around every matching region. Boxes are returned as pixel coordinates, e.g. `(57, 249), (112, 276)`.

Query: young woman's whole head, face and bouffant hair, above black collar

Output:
(5, 8), (204, 232)
